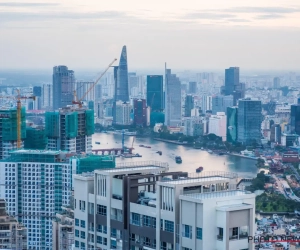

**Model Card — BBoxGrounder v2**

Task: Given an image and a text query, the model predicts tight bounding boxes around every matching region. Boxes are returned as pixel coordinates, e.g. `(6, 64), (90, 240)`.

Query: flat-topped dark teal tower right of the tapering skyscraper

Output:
(147, 75), (164, 112)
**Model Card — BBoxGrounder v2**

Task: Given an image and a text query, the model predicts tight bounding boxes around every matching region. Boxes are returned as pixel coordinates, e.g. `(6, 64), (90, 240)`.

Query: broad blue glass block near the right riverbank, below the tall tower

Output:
(237, 98), (262, 145)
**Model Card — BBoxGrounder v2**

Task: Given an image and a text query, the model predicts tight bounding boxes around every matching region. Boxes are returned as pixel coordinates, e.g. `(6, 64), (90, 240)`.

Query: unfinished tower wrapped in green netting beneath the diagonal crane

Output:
(46, 106), (95, 154)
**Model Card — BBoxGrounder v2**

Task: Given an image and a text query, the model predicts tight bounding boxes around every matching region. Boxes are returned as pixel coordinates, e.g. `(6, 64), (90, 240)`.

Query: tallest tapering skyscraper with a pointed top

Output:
(115, 46), (129, 102)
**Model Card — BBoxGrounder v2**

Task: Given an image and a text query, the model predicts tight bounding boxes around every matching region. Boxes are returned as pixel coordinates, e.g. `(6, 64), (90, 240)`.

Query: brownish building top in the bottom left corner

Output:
(0, 199), (27, 250)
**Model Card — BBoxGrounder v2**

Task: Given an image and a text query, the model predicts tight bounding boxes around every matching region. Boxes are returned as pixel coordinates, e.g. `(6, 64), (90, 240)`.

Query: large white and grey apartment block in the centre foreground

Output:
(74, 162), (255, 250)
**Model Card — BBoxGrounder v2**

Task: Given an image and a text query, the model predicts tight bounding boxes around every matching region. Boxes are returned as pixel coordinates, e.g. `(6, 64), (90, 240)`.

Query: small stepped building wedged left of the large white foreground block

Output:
(52, 195), (74, 250)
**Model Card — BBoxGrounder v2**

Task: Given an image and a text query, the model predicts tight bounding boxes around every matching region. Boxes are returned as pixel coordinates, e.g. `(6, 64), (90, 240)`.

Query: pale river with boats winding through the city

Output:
(93, 133), (258, 178)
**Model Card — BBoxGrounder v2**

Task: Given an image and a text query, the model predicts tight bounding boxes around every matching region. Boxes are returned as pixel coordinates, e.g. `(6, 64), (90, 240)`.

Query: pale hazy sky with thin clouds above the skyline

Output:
(0, 0), (300, 70)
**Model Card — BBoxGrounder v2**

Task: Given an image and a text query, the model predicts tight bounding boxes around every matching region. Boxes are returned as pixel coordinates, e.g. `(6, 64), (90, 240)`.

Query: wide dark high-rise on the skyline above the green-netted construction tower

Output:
(52, 66), (75, 110)
